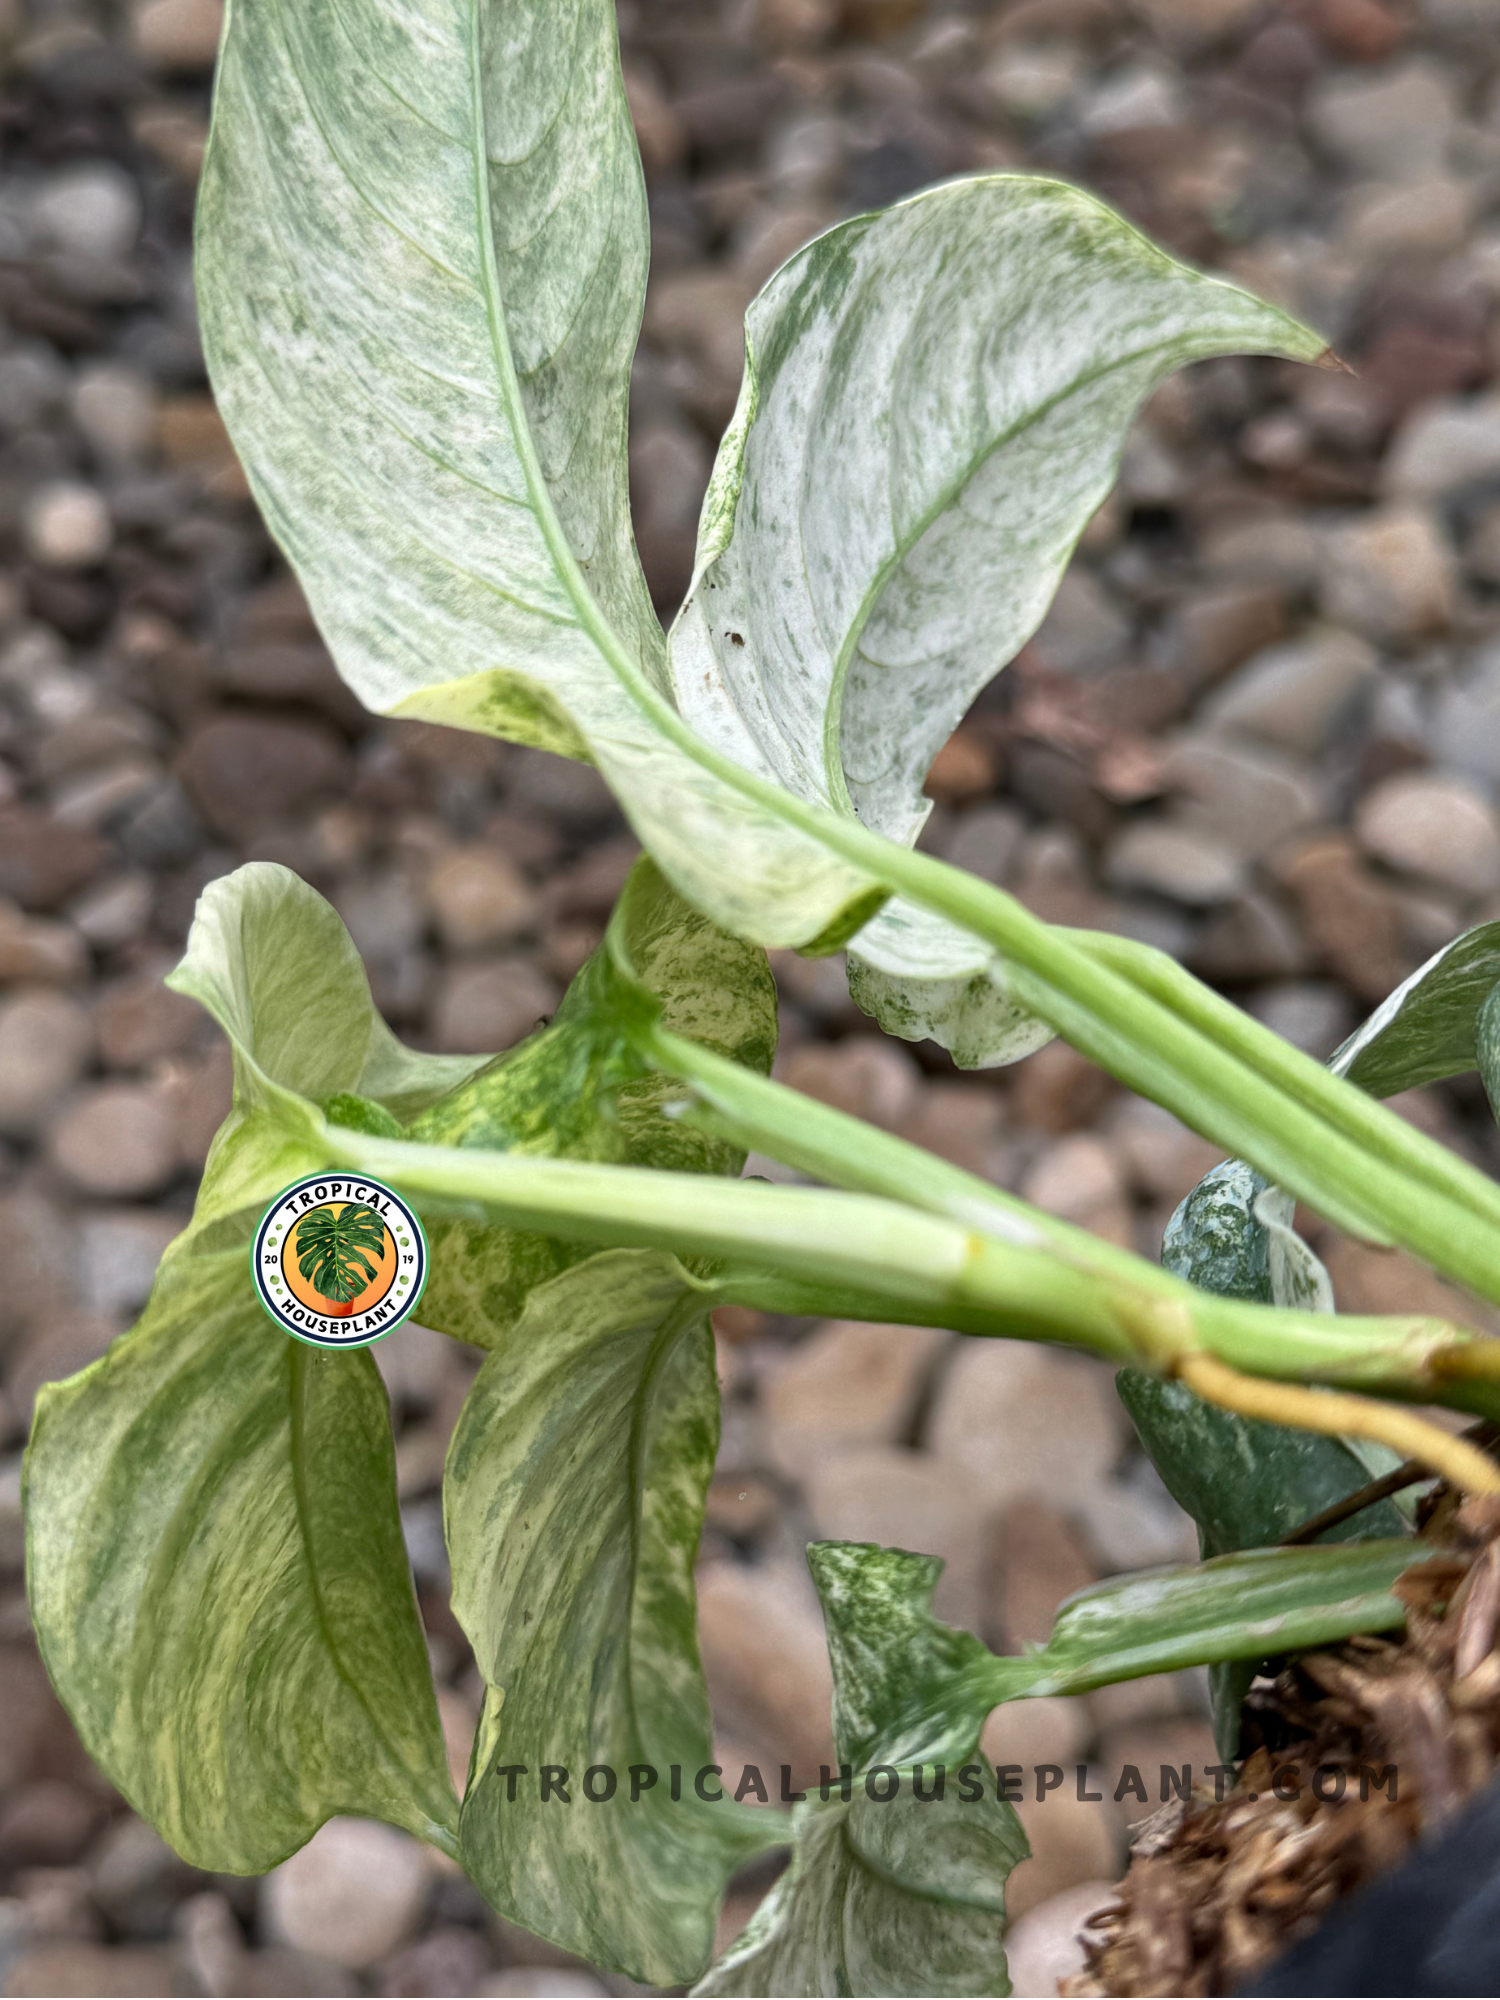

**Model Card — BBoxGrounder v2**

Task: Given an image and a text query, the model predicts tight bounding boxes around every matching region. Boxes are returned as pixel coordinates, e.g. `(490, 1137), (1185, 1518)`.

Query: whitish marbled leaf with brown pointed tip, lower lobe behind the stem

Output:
(672, 174), (1322, 1064)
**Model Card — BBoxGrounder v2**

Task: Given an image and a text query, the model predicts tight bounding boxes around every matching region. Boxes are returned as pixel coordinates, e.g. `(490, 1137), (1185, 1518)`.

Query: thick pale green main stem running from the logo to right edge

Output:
(338, 1126), (1500, 1414)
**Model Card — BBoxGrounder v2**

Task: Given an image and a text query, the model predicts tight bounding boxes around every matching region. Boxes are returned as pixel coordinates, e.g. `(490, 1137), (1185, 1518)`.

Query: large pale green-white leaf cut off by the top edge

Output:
(196, 0), (870, 944)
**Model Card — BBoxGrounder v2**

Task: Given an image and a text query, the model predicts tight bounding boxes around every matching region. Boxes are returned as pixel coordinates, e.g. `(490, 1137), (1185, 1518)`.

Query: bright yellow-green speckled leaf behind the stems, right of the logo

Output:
(408, 860), (776, 1346)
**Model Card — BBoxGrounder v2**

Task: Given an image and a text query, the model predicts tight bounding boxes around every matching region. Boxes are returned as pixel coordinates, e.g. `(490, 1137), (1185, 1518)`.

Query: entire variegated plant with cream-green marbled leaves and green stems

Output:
(26, 0), (1500, 1994)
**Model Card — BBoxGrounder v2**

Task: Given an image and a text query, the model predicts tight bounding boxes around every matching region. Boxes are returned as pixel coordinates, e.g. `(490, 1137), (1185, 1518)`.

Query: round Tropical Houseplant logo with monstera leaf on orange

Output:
(250, 1174), (428, 1348)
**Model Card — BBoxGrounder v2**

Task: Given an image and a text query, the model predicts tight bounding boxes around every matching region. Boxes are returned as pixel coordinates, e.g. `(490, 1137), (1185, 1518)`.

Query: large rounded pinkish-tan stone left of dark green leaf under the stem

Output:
(928, 1340), (1124, 1508)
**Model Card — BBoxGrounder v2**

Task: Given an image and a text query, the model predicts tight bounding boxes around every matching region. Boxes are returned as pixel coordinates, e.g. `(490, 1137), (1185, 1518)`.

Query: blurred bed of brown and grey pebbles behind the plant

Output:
(0, 0), (1500, 1994)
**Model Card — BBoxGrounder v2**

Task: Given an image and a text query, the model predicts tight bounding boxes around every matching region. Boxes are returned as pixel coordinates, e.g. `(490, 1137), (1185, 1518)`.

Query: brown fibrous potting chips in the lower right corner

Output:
(1062, 1492), (1500, 2000)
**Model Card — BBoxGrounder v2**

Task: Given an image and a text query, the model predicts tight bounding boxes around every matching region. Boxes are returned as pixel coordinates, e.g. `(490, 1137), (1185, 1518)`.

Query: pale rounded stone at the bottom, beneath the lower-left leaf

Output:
(260, 1820), (432, 1972)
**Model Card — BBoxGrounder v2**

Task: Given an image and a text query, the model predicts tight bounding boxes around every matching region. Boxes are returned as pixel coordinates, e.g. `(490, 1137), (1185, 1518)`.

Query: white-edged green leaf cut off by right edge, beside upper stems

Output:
(1328, 924), (1500, 1098)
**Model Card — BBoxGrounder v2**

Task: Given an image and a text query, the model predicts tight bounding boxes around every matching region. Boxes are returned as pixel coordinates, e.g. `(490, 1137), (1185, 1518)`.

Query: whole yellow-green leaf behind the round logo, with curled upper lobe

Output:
(26, 864), (472, 1872)
